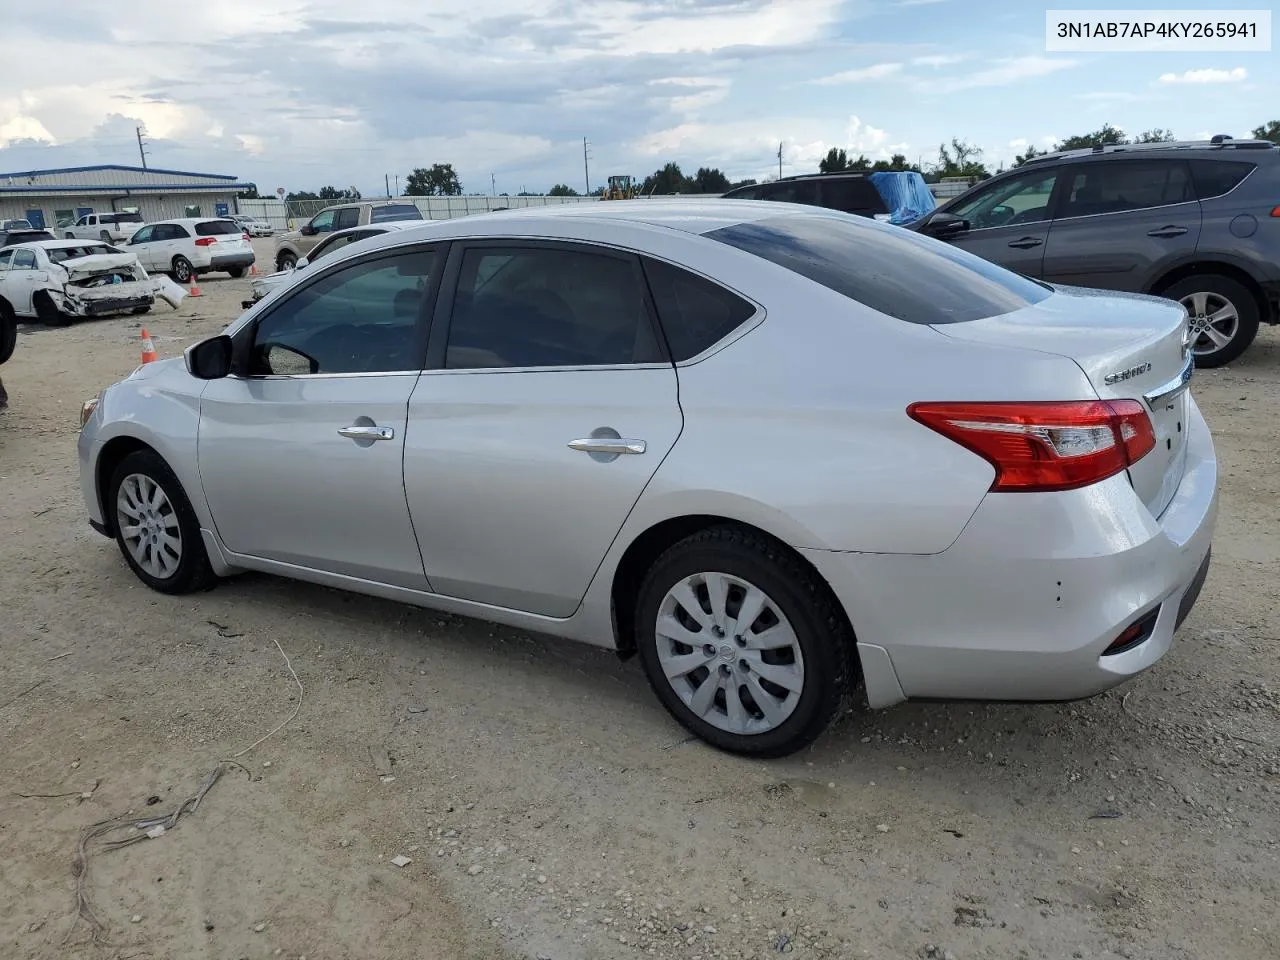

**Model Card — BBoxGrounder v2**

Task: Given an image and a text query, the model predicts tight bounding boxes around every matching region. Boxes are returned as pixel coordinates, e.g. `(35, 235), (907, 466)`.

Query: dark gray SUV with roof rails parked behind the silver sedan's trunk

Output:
(909, 136), (1280, 367)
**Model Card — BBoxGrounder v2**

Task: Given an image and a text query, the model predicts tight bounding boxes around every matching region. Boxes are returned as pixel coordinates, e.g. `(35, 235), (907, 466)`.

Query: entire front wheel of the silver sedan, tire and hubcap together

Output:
(102, 449), (218, 594)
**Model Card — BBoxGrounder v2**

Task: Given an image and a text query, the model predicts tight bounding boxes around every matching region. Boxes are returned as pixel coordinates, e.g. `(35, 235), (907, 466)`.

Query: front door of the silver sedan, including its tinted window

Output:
(197, 246), (444, 590)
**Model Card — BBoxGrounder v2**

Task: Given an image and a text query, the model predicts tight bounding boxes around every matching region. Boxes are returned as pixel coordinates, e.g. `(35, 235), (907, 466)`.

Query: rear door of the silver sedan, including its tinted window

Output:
(404, 241), (684, 617)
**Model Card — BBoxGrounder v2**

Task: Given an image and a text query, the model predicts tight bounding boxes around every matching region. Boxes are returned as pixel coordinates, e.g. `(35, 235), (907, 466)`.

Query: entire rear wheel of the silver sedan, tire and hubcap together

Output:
(635, 526), (859, 758)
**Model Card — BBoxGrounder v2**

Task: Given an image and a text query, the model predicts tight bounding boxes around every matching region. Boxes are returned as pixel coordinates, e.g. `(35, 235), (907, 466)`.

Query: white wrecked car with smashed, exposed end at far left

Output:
(0, 239), (187, 325)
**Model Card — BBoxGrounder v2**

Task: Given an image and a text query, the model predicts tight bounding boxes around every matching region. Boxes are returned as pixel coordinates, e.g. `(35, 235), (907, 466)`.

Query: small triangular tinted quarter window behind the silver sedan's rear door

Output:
(644, 259), (755, 364)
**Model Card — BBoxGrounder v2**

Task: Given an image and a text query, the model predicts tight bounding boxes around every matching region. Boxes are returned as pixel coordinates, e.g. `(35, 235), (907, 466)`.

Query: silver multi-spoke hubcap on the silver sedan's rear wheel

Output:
(657, 573), (804, 733)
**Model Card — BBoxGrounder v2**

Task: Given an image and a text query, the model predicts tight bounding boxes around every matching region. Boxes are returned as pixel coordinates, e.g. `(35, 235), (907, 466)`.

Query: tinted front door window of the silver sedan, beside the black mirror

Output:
(250, 250), (440, 376)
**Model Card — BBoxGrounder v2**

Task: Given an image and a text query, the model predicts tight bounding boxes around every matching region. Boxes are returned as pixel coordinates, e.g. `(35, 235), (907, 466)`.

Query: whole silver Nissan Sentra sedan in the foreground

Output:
(78, 200), (1217, 756)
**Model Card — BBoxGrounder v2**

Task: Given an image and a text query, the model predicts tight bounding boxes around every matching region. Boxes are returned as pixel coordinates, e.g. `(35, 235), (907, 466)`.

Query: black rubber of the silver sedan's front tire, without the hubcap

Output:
(102, 451), (218, 594)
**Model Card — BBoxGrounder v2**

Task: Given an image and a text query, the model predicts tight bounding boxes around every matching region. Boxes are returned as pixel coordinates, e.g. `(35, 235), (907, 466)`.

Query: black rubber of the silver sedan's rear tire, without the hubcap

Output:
(635, 525), (859, 758)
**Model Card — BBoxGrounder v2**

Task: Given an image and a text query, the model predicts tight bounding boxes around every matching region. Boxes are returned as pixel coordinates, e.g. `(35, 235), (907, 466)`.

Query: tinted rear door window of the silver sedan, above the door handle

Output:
(444, 247), (662, 369)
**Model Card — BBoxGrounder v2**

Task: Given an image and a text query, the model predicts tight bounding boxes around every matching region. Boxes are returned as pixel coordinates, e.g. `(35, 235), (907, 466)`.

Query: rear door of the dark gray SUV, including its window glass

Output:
(1044, 157), (1201, 293)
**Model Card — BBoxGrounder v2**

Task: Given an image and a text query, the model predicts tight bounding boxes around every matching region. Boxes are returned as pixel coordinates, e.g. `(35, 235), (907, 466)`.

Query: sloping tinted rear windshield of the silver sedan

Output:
(707, 215), (1052, 324)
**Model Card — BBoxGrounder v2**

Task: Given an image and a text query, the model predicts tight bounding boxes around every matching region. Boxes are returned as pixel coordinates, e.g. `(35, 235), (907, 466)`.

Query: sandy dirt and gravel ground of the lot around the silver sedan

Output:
(0, 241), (1280, 960)
